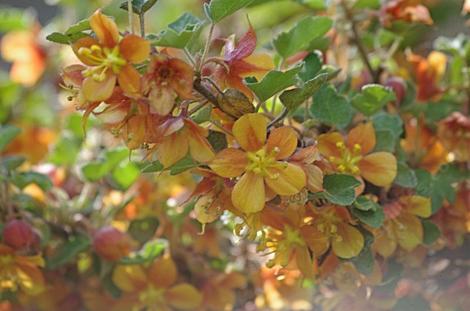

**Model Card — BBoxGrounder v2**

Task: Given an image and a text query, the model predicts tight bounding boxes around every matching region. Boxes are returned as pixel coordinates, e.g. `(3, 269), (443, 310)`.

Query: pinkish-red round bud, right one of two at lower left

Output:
(93, 227), (133, 261)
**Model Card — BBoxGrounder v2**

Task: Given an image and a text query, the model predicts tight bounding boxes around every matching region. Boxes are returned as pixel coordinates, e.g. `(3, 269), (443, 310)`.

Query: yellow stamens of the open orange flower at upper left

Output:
(78, 45), (126, 82)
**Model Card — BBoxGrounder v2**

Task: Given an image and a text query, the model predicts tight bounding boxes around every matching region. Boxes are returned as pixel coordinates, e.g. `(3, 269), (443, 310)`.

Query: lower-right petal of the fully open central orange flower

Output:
(265, 163), (307, 195)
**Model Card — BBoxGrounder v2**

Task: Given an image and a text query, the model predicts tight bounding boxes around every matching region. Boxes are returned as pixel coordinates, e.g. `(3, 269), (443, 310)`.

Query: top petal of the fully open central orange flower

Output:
(232, 113), (268, 151)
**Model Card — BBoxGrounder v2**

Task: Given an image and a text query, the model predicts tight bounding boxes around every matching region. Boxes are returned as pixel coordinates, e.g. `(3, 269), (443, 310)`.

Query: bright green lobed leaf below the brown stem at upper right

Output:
(351, 84), (396, 116)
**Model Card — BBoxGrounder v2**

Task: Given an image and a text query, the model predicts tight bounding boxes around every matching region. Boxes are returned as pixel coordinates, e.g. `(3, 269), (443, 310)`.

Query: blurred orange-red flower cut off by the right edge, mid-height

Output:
(438, 112), (470, 162)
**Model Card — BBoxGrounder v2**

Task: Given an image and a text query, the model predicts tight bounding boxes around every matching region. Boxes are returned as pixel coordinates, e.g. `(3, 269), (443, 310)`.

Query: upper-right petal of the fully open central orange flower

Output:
(266, 126), (297, 160)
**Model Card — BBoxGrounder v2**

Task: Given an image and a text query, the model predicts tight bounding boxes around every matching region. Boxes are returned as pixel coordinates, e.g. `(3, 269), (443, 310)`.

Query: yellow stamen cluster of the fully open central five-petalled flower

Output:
(246, 148), (286, 179)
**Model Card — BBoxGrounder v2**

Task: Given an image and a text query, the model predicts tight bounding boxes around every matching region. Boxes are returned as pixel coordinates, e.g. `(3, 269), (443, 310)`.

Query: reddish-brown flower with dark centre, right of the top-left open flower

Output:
(144, 53), (194, 115)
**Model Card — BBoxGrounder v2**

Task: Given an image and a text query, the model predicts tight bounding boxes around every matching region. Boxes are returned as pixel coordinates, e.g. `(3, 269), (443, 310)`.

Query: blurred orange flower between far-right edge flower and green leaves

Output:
(401, 119), (447, 172)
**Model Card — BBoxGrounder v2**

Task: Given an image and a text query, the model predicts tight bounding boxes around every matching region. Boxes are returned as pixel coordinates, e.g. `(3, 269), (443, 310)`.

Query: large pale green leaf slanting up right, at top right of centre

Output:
(273, 16), (333, 59)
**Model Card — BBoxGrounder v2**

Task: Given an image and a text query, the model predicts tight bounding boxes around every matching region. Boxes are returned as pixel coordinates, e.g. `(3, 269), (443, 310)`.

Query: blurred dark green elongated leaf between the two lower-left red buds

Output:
(46, 234), (91, 269)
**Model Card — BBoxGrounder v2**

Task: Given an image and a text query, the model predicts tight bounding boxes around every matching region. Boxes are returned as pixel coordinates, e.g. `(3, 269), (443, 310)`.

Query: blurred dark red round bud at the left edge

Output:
(2, 219), (39, 250)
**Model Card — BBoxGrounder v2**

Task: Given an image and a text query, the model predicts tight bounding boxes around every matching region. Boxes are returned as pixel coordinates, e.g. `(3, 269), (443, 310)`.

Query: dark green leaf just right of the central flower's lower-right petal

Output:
(323, 174), (361, 205)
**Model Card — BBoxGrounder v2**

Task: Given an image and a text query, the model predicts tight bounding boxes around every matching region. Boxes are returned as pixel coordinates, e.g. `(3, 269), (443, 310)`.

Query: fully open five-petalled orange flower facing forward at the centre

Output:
(209, 113), (307, 213)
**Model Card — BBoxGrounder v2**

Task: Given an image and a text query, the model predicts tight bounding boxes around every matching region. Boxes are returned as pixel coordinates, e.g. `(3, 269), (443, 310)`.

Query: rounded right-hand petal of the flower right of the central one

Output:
(358, 152), (397, 187)
